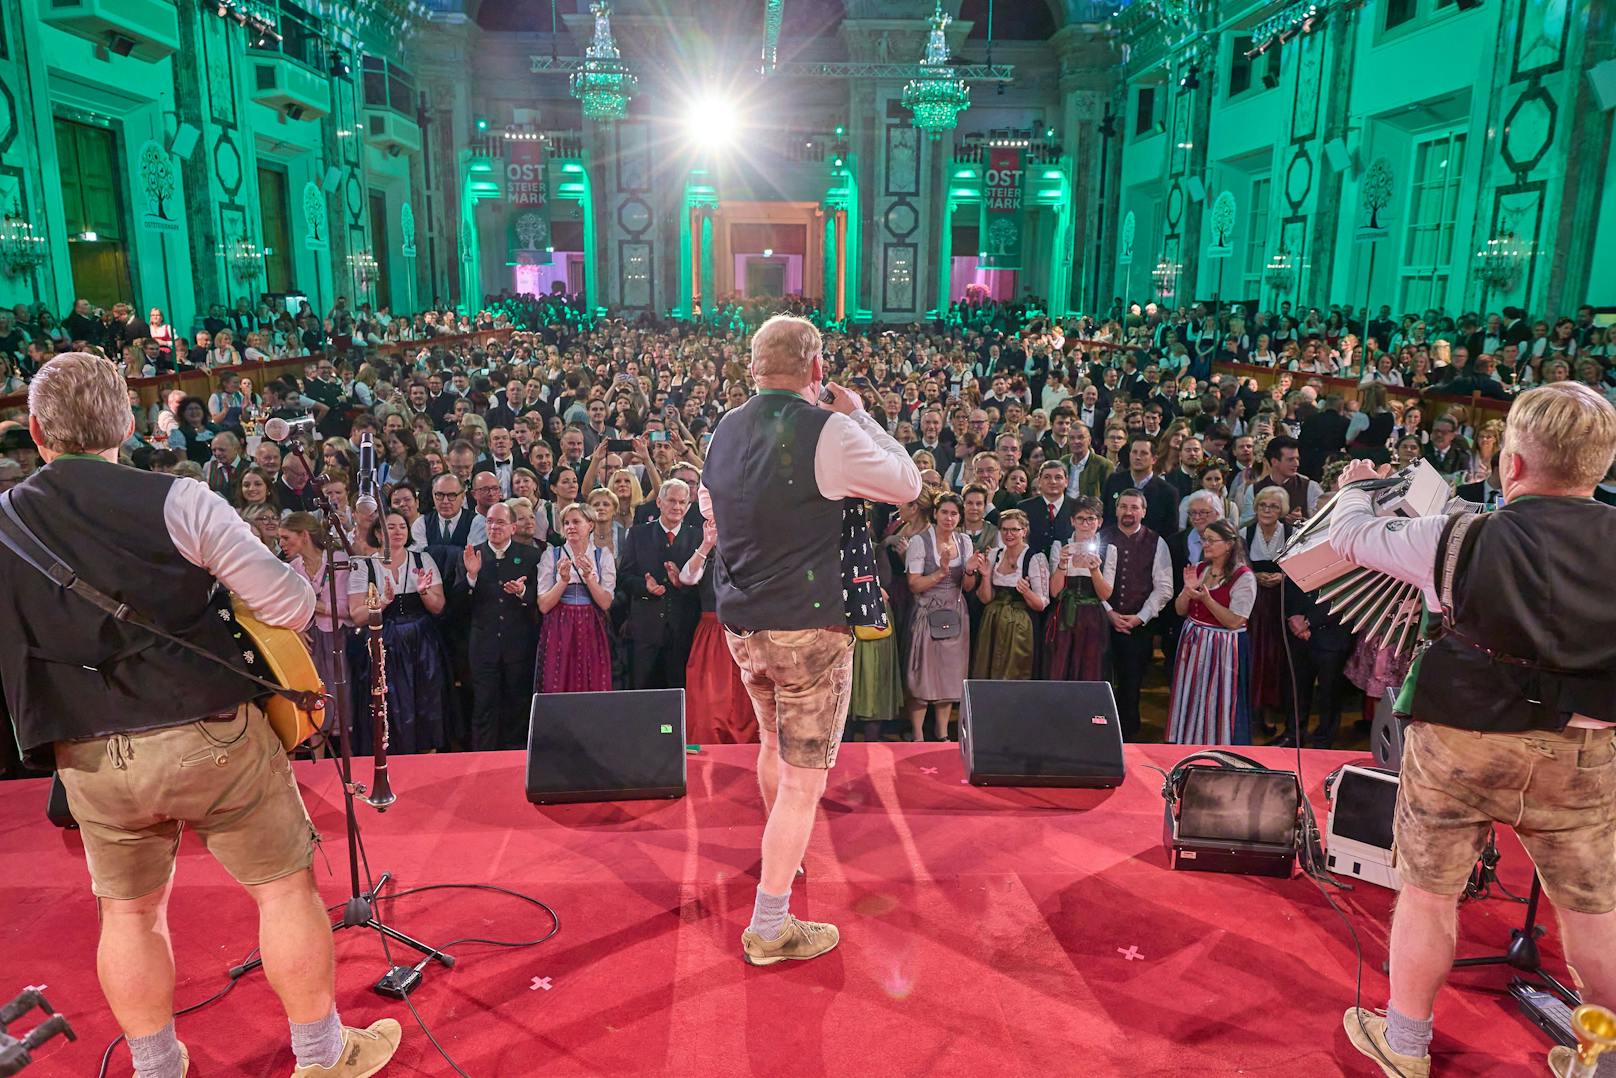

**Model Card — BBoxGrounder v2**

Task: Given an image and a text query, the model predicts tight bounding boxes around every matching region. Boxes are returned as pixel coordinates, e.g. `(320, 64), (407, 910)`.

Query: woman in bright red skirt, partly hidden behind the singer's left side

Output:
(681, 513), (756, 745)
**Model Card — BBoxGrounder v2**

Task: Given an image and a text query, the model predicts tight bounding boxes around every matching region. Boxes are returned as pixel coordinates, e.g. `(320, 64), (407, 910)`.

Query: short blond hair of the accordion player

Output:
(1503, 381), (1616, 490)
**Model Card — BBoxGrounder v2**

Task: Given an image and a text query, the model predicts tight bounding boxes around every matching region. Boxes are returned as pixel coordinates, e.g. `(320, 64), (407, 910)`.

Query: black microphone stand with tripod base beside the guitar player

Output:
(231, 435), (454, 999)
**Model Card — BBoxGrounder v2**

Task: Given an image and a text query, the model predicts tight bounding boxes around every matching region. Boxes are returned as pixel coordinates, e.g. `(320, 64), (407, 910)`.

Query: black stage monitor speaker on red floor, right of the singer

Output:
(960, 680), (1123, 789)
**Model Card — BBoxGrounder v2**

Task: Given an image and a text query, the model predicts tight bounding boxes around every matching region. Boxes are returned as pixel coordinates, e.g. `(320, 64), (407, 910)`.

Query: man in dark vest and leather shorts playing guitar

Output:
(0, 360), (399, 1078)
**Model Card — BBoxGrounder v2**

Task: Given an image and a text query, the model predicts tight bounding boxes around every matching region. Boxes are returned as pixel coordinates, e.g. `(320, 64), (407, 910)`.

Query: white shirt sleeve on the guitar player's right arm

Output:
(163, 478), (314, 629)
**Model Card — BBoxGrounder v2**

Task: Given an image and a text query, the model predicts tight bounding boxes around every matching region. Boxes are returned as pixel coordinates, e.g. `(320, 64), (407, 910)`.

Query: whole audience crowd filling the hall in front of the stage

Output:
(0, 286), (1616, 775)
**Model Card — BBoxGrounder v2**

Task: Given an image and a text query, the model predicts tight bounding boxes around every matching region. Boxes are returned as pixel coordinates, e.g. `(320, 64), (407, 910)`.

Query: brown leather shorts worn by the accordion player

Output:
(1393, 722), (1616, 913)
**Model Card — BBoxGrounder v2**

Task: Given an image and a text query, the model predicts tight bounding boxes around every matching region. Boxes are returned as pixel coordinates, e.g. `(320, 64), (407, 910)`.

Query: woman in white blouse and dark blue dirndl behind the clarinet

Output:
(347, 509), (454, 755)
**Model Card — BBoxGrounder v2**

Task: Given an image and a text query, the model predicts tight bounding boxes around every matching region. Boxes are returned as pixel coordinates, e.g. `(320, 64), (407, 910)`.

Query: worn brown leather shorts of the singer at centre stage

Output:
(724, 629), (853, 768)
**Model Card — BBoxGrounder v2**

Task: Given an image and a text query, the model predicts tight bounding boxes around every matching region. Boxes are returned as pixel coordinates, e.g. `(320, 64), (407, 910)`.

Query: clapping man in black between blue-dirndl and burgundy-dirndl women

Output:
(456, 503), (538, 752)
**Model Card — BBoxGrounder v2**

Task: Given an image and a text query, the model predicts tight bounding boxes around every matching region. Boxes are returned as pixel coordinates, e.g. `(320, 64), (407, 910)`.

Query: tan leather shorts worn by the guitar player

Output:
(57, 705), (320, 900)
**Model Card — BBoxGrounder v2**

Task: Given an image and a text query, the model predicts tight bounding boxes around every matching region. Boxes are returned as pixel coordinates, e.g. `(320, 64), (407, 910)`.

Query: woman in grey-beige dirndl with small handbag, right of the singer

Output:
(903, 491), (976, 742)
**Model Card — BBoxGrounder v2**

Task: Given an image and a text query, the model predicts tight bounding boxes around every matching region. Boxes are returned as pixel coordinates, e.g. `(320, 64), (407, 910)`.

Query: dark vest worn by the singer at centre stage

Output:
(701, 393), (847, 629)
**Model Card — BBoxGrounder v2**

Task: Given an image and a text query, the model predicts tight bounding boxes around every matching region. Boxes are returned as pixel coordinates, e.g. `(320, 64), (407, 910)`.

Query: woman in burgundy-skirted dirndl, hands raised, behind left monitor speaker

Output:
(533, 501), (617, 692)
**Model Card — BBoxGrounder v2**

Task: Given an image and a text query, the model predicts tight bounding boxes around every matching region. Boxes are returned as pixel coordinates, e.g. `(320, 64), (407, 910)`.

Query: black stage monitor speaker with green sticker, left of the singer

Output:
(527, 688), (685, 805)
